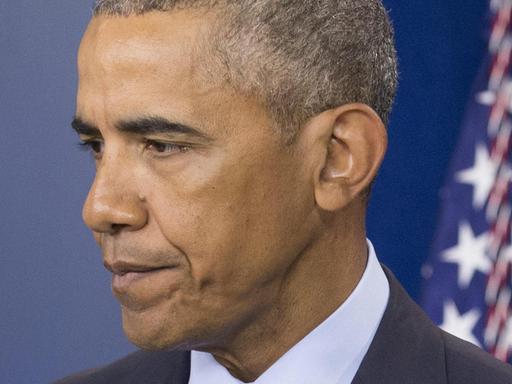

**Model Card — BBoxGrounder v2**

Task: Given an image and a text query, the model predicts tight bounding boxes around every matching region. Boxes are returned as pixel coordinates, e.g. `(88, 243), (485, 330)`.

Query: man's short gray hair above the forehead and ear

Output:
(94, 0), (398, 134)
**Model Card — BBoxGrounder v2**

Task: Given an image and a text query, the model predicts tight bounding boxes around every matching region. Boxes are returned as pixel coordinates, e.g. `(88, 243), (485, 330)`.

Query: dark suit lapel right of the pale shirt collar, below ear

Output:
(352, 267), (447, 384)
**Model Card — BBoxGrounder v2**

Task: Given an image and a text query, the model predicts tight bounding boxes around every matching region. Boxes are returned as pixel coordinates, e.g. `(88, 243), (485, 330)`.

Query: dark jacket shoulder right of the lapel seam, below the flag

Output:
(441, 331), (512, 384)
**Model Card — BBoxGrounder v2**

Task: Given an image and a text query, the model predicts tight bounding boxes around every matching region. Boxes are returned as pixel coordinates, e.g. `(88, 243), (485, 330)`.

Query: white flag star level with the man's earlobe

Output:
(456, 143), (498, 209)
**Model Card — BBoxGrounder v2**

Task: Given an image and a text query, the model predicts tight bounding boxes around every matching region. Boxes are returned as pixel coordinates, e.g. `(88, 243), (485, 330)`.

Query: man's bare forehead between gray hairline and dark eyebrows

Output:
(77, 11), (226, 130)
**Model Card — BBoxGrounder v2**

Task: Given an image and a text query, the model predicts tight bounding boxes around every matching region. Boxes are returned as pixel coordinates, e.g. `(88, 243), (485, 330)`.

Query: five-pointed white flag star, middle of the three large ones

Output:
(442, 222), (492, 289)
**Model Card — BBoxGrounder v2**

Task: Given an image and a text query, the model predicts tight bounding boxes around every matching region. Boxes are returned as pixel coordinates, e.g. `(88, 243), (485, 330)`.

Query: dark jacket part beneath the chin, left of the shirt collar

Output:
(54, 351), (190, 384)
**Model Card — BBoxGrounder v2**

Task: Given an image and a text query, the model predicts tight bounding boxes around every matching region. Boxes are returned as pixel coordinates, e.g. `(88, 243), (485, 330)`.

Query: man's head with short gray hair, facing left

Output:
(74, 0), (396, 349)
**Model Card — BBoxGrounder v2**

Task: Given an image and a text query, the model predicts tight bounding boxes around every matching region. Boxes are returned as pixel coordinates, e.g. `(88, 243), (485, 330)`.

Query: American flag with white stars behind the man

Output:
(422, 0), (512, 363)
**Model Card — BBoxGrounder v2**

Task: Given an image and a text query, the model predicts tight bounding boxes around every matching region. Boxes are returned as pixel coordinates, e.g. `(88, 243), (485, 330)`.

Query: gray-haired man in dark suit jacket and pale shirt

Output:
(57, 0), (512, 384)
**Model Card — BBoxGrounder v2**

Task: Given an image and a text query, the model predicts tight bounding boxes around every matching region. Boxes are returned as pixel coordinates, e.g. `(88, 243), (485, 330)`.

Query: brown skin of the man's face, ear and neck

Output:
(77, 10), (386, 381)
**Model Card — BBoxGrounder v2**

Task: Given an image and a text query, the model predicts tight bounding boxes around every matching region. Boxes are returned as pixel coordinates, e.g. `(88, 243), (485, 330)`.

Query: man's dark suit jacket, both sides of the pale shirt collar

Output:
(55, 269), (512, 384)
